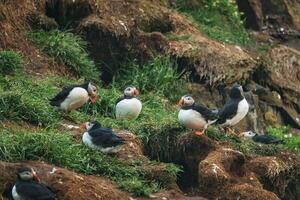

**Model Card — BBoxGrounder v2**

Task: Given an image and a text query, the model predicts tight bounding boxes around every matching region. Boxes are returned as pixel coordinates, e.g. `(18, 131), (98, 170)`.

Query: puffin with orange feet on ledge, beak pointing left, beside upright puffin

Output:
(178, 95), (218, 135)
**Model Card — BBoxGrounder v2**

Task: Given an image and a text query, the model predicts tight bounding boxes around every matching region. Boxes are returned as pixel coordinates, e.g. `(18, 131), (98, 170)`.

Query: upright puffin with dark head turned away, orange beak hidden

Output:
(217, 84), (249, 133)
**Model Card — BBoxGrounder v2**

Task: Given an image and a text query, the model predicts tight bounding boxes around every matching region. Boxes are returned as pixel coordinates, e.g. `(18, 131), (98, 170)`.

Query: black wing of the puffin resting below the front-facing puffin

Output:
(89, 128), (124, 148)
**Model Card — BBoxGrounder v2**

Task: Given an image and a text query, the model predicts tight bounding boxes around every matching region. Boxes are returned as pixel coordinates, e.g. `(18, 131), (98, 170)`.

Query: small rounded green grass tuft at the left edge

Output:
(0, 50), (23, 75)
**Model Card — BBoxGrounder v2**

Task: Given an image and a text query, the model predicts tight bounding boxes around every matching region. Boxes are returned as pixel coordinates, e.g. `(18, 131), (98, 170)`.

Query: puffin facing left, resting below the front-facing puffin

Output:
(80, 121), (125, 153)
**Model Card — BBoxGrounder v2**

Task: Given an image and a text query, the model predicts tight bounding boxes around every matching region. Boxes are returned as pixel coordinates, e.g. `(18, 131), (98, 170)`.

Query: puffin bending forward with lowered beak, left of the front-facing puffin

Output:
(50, 83), (97, 112)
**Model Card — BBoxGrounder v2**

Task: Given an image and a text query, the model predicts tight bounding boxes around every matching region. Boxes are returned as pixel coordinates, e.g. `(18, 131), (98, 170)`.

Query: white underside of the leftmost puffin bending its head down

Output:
(60, 87), (89, 111)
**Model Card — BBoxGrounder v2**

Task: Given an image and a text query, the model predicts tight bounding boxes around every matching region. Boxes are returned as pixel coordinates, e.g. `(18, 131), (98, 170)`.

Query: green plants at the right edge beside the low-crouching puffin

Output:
(267, 126), (300, 155)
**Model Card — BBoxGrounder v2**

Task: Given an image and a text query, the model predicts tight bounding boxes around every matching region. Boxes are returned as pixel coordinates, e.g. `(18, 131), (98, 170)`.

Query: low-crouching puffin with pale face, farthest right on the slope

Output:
(239, 131), (284, 144)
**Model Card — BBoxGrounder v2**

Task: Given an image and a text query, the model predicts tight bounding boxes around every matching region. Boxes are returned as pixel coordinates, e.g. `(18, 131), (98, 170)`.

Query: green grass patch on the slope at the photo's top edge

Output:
(176, 0), (251, 45)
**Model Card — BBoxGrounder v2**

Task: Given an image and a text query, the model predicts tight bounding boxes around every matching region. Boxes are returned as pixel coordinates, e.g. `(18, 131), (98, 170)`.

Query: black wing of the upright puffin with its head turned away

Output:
(217, 99), (239, 124)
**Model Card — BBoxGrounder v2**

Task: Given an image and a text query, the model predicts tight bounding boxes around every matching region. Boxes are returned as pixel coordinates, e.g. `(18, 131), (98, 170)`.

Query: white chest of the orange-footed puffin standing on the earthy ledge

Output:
(178, 109), (208, 130)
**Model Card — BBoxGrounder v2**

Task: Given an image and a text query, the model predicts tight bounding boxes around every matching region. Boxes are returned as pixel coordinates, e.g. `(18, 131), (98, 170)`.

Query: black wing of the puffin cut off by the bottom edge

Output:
(16, 181), (56, 200)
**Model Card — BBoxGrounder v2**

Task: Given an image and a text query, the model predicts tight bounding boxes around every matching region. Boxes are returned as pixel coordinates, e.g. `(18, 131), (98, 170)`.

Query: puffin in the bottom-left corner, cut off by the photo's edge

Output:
(11, 167), (56, 200)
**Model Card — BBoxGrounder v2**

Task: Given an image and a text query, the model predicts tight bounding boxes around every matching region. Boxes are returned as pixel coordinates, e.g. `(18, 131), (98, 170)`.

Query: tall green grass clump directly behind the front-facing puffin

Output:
(113, 56), (185, 100)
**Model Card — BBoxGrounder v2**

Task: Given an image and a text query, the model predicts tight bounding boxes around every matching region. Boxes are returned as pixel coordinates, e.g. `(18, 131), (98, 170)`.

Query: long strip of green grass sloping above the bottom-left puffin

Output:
(0, 129), (161, 196)
